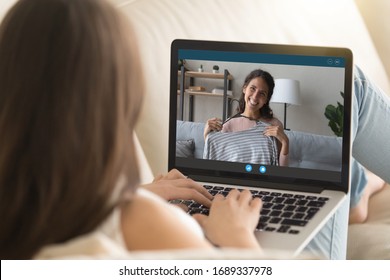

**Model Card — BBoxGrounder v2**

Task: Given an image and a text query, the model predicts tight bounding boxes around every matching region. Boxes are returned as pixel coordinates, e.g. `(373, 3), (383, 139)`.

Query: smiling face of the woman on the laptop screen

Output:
(243, 77), (269, 119)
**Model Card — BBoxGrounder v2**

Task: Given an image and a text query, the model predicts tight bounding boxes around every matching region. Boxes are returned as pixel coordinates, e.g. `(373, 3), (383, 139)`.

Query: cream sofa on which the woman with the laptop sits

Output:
(0, 0), (390, 259)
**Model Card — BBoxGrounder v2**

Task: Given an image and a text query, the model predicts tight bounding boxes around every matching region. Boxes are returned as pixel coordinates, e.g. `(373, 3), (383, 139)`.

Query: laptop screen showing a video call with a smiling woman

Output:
(169, 40), (352, 192)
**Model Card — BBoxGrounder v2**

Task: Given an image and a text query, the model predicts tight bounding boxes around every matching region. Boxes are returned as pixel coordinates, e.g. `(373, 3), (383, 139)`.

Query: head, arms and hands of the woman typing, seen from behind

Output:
(0, 0), (261, 259)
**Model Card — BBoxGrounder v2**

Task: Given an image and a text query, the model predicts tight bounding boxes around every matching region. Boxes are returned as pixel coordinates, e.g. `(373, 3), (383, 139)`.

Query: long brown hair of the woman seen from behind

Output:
(0, 0), (143, 259)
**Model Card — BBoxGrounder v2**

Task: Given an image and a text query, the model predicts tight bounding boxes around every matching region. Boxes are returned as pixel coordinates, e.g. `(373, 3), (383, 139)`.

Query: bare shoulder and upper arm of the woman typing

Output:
(121, 188), (209, 250)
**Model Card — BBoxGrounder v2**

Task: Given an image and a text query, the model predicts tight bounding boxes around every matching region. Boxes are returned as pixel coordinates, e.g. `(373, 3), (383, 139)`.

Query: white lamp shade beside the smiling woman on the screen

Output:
(271, 79), (301, 105)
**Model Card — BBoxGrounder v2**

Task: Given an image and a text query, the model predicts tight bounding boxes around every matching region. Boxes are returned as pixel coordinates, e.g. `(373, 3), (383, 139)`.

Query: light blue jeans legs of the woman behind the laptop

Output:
(305, 64), (390, 259)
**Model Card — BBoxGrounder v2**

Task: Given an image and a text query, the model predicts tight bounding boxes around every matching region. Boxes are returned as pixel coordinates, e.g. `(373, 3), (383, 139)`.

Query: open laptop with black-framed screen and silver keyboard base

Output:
(168, 39), (353, 255)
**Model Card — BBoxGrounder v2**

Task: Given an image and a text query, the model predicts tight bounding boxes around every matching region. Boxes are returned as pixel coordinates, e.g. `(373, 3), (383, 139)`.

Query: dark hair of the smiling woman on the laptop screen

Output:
(237, 69), (275, 119)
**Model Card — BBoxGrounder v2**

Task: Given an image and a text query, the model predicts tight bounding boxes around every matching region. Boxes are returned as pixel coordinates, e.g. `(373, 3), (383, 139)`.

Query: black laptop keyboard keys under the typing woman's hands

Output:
(175, 185), (329, 234)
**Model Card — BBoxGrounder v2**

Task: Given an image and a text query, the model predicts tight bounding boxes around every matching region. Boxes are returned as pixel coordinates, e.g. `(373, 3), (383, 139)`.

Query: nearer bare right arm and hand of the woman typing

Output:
(121, 186), (261, 250)
